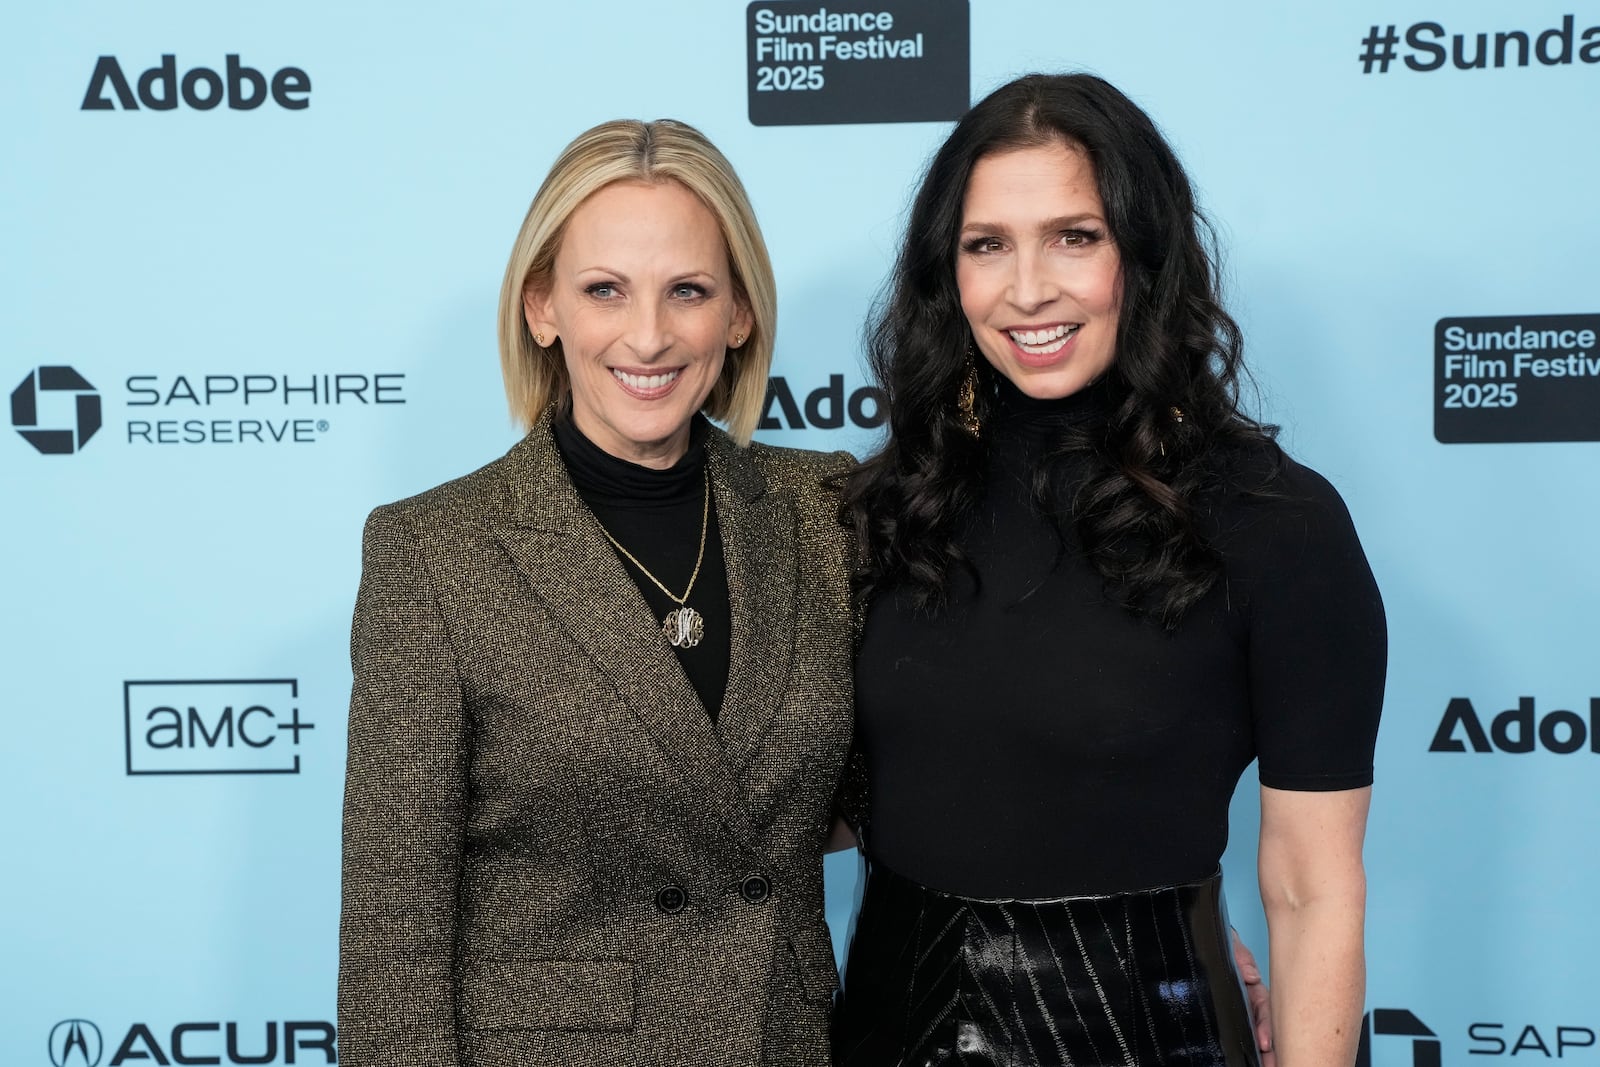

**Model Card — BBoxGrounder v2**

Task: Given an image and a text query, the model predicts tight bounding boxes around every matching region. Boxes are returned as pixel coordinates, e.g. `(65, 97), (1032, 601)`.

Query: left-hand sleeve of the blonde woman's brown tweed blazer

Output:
(338, 507), (467, 1067)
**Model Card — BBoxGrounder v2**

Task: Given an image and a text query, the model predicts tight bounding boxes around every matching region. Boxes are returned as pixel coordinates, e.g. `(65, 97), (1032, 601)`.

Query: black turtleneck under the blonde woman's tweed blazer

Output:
(550, 416), (733, 718)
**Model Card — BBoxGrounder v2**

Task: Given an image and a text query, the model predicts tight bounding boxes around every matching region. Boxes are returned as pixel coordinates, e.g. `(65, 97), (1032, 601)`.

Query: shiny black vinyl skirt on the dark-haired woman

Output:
(834, 864), (1261, 1067)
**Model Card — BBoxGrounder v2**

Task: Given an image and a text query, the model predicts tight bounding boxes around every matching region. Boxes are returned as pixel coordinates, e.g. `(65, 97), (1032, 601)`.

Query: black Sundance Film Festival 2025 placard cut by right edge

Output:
(1434, 315), (1600, 445)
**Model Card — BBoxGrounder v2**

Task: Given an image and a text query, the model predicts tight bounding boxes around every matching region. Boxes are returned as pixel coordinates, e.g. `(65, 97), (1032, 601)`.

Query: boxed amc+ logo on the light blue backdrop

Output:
(122, 678), (315, 774)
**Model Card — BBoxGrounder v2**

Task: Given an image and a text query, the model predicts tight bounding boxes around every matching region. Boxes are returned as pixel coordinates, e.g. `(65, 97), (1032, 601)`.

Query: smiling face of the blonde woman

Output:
(523, 181), (750, 467)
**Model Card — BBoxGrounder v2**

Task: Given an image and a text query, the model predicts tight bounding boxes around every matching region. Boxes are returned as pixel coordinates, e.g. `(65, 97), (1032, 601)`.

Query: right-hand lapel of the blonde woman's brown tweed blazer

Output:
(706, 432), (798, 768)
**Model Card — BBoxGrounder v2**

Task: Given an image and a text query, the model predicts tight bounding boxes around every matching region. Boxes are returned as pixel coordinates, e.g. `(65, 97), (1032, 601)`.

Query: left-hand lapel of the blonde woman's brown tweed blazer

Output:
(494, 416), (754, 837)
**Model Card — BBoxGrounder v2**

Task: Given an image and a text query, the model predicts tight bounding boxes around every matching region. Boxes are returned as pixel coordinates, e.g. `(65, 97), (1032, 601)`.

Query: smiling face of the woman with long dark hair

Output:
(955, 141), (1122, 400)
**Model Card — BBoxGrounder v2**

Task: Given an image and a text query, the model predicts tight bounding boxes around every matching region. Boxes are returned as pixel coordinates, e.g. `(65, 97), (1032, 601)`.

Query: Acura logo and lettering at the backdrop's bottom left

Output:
(50, 1019), (338, 1067)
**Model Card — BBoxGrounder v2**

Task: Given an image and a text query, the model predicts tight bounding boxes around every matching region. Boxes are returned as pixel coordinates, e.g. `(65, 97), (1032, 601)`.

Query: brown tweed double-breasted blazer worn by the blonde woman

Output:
(339, 419), (851, 1067)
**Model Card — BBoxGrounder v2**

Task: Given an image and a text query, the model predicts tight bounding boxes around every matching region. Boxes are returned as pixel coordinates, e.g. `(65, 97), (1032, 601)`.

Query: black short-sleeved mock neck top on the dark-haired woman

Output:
(856, 381), (1386, 897)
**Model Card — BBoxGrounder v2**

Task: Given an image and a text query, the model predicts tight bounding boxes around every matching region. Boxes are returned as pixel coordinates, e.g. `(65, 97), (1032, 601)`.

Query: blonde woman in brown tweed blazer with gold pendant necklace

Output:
(339, 122), (851, 1067)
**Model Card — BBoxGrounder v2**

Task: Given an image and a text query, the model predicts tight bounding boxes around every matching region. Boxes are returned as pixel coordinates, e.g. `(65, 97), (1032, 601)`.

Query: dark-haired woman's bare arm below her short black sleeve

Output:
(1258, 787), (1373, 1067)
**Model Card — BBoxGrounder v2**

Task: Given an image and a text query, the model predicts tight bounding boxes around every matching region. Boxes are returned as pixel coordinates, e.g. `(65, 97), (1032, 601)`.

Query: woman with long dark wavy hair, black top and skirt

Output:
(835, 75), (1386, 1067)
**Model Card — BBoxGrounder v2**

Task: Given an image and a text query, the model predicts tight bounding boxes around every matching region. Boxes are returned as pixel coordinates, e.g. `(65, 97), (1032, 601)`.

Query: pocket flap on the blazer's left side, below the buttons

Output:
(461, 960), (634, 1030)
